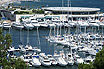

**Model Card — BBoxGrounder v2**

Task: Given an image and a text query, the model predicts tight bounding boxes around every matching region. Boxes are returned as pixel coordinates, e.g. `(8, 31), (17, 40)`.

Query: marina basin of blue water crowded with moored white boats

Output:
(1, 7), (104, 69)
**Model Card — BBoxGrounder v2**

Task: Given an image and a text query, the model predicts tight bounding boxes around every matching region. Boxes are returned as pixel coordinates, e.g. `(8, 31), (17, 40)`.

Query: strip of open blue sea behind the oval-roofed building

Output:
(14, 0), (104, 11)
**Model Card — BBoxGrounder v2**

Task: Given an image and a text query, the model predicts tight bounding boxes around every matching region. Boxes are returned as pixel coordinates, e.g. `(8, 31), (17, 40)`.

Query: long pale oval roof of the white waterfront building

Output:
(42, 7), (100, 12)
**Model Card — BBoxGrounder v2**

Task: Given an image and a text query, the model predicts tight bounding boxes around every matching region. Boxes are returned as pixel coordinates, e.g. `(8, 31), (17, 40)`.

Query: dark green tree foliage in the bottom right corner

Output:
(78, 48), (104, 69)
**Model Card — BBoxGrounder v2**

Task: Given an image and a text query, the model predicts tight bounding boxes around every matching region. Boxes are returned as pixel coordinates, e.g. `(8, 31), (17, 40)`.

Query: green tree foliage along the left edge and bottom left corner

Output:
(0, 29), (29, 69)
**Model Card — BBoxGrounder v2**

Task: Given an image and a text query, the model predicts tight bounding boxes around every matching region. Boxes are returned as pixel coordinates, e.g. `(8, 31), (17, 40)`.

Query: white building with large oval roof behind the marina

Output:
(42, 7), (104, 20)
